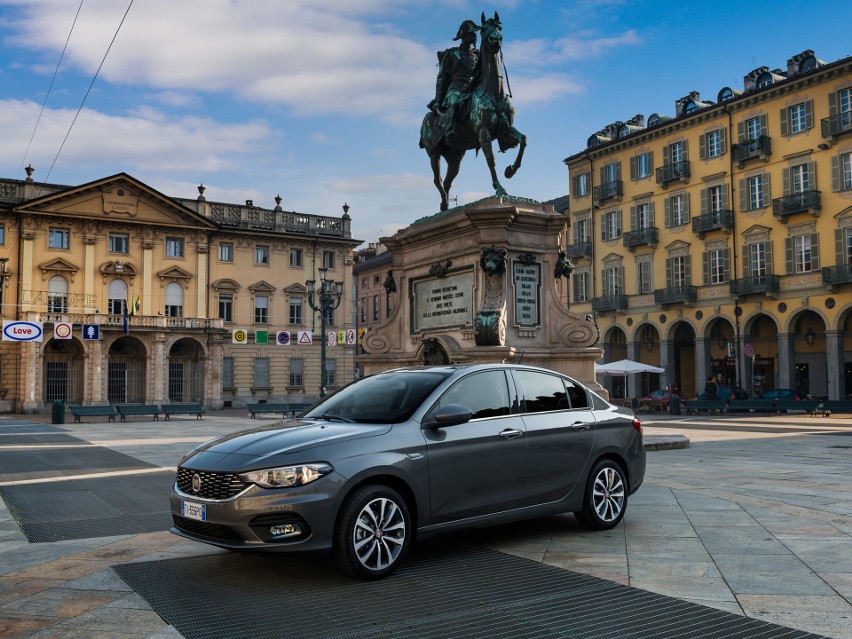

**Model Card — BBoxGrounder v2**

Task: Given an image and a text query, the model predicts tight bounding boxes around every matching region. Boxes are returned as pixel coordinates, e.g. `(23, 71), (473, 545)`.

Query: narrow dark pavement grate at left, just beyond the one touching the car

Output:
(0, 446), (157, 482)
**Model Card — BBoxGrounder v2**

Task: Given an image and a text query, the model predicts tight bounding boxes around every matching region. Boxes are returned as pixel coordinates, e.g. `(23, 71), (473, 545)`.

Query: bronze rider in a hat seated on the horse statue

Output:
(427, 20), (480, 142)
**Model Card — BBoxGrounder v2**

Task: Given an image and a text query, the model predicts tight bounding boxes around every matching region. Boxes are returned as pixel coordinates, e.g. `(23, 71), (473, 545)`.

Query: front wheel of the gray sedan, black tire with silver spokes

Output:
(334, 486), (412, 580)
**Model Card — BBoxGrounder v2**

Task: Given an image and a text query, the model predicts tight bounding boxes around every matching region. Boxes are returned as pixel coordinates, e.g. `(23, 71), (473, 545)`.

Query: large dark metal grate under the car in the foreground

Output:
(114, 539), (818, 639)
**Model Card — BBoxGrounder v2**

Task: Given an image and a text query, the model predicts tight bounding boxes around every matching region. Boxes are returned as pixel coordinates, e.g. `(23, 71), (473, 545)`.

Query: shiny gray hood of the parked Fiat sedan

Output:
(182, 419), (390, 470)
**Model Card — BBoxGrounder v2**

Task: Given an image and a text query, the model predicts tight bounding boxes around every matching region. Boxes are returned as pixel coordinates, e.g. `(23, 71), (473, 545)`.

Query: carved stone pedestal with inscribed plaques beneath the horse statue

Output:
(357, 197), (606, 395)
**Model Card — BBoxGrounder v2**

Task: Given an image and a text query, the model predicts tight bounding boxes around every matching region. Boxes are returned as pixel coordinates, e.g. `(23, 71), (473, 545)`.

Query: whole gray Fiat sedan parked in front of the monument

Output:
(171, 364), (645, 579)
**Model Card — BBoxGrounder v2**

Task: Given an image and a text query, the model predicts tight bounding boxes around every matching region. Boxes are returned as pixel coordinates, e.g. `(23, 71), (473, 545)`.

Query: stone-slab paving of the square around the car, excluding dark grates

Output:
(0, 410), (852, 639)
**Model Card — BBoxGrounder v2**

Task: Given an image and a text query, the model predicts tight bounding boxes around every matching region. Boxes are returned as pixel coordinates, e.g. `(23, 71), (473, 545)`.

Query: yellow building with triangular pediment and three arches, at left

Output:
(0, 167), (359, 412)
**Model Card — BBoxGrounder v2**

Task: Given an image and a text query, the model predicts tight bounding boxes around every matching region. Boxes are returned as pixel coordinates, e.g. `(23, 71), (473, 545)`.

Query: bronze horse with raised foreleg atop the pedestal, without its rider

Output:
(420, 12), (527, 211)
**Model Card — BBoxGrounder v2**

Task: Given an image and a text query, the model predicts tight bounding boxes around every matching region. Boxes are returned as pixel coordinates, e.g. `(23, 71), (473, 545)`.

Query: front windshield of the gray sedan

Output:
(302, 371), (449, 424)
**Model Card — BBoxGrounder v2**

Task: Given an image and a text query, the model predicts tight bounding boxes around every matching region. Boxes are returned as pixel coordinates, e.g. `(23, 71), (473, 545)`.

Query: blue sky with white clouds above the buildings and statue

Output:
(0, 0), (852, 248)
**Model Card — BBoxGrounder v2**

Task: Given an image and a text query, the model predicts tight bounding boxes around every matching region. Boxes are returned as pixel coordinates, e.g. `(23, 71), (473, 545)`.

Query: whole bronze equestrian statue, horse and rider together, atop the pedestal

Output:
(420, 12), (527, 211)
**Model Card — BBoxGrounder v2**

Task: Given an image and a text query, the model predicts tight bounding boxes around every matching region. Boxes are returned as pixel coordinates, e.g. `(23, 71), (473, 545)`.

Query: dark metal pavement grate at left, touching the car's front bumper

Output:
(0, 472), (174, 543)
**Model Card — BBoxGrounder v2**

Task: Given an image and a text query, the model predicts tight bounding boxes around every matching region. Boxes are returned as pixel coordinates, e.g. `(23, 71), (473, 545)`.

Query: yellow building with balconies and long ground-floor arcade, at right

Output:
(565, 51), (852, 399)
